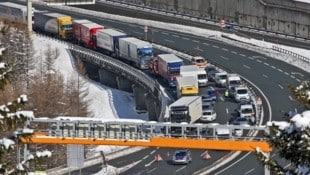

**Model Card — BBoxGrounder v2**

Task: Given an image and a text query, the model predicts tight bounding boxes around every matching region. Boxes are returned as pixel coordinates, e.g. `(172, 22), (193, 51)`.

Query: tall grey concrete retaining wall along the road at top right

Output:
(125, 0), (310, 39)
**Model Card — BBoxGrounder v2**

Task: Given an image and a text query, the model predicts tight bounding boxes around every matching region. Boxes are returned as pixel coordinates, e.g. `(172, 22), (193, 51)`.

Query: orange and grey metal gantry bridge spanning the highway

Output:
(20, 117), (272, 152)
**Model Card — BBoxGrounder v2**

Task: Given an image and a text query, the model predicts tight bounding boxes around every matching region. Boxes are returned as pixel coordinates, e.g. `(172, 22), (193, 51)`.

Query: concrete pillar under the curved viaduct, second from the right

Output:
(132, 84), (147, 112)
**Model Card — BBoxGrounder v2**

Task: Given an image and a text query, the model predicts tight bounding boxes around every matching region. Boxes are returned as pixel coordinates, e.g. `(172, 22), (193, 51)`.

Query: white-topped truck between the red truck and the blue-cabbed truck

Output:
(97, 29), (128, 57)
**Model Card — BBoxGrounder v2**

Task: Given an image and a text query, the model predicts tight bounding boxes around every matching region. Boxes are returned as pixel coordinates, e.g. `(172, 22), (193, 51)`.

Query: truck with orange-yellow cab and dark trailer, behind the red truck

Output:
(33, 11), (72, 40)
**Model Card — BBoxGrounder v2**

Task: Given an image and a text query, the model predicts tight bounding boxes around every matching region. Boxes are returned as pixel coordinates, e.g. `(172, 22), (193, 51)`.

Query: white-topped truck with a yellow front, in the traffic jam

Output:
(176, 76), (199, 98)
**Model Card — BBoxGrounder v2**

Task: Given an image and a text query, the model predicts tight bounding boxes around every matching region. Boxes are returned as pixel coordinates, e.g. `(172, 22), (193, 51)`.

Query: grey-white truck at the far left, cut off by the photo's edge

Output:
(0, 2), (35, 24)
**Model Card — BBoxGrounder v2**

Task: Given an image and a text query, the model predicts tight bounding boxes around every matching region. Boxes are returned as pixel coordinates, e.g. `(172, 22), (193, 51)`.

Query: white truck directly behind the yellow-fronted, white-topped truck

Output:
(180, 65), (208, 86)
